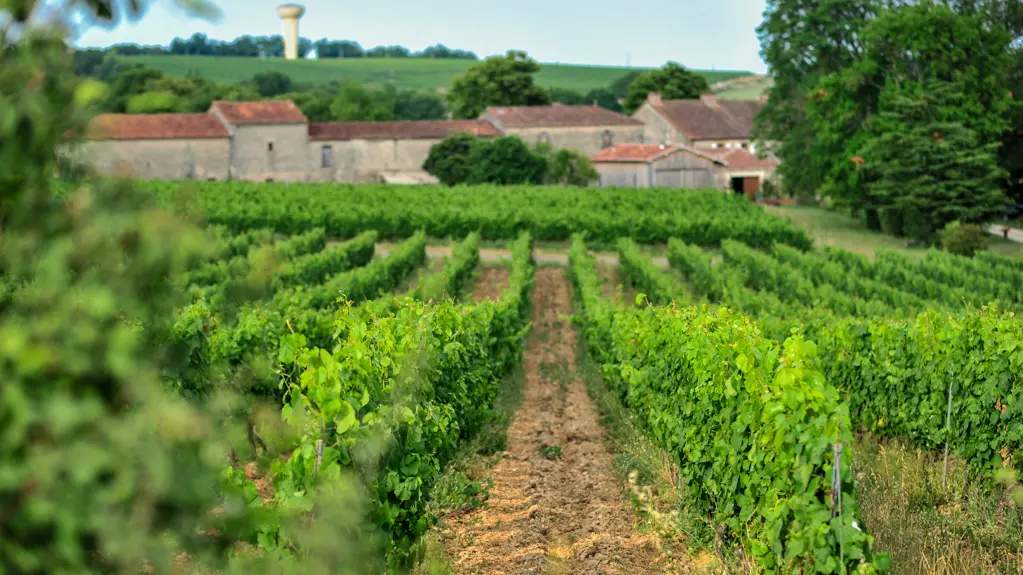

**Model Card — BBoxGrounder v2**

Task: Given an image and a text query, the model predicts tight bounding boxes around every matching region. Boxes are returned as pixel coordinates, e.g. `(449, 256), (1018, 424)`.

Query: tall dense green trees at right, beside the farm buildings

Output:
(757, 0), (1023, 244)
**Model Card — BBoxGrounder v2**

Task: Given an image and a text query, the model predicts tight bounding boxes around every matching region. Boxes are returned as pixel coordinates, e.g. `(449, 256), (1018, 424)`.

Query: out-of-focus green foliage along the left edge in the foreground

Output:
(0, 0), (380, 574)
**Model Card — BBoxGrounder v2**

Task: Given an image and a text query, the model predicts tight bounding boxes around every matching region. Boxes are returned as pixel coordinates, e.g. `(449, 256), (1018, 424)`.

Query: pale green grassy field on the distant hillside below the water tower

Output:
(121, 56), (750, 92)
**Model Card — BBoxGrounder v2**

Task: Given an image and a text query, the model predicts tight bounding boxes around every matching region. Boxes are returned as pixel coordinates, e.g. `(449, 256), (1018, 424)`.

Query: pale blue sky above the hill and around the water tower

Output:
(76, 0), (766, 74)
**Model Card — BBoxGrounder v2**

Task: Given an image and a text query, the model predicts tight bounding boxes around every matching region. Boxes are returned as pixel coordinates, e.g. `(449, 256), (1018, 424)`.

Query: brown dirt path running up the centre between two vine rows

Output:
(444, 267), (667, 575)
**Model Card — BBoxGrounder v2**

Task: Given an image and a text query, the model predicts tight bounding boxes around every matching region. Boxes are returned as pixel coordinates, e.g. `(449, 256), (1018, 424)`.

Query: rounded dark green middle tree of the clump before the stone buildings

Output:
(465, 136), (547, 185)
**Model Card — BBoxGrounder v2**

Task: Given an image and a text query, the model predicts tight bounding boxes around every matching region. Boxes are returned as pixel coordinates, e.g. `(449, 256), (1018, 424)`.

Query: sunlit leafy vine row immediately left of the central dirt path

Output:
(245, 230), (533, 566)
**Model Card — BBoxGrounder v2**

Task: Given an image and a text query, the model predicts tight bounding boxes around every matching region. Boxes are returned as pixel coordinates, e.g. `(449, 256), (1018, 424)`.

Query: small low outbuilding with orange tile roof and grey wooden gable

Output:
(590, 144), (726, 189)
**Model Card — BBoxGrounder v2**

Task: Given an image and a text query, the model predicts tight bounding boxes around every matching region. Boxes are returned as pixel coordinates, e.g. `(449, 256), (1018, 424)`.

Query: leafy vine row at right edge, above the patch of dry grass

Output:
(806, 308), (1023, 480)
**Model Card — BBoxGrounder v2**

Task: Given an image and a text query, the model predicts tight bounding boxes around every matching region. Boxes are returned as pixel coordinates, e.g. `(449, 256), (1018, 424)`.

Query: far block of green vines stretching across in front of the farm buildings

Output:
(121, 181), (813, 250)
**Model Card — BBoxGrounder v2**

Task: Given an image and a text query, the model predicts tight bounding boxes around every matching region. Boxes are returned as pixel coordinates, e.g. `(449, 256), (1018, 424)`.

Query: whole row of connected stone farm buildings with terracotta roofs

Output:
(79, 94), (775, 191)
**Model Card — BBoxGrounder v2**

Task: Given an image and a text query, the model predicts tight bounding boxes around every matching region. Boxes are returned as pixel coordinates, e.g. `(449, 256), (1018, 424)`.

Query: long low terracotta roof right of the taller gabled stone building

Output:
(309, 120), (501, 140)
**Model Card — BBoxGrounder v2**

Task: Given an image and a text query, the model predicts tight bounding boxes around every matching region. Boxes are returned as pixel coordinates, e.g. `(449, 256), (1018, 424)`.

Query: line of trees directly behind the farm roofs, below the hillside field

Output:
(73, 50), (709, 122)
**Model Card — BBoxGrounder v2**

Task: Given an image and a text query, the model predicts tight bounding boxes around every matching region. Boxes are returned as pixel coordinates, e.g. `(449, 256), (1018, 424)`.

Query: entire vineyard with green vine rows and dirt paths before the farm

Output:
(9, 181), (1023, 574)
